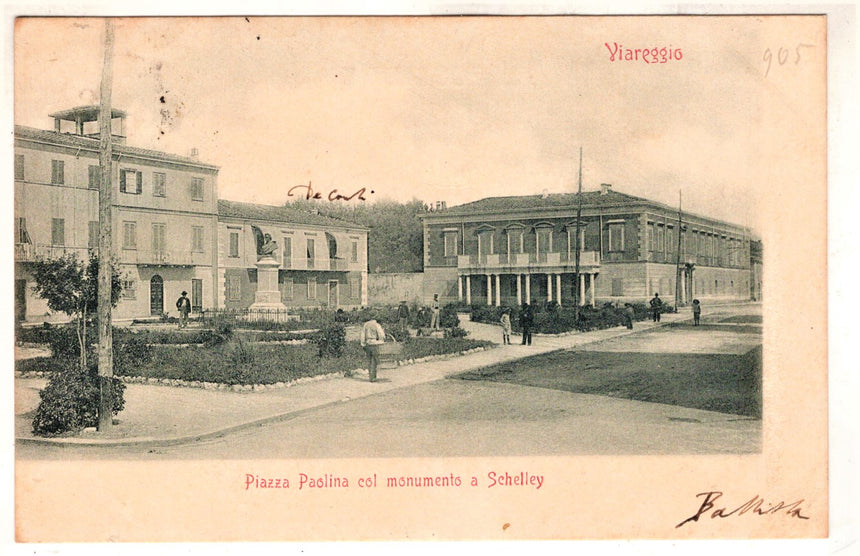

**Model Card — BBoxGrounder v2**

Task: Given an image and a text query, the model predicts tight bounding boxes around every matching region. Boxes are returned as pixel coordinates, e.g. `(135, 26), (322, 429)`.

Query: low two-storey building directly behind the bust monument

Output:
(218, 200), (367, 309)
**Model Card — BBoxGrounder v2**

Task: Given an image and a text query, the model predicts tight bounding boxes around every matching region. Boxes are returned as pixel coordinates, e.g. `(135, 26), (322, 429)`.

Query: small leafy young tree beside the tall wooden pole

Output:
(31, 253), (122, 370)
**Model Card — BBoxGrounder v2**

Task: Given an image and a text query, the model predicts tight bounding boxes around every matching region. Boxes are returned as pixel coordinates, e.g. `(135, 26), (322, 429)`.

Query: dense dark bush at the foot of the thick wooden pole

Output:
(33, 358), (125, 436)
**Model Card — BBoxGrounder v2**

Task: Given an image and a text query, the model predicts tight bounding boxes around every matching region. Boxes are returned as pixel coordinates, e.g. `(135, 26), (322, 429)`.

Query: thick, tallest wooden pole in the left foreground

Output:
(98, 18), (114, 432)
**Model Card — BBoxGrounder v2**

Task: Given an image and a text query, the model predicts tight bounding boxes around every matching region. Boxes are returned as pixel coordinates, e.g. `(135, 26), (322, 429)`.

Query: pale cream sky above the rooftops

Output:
(15, 17), (824, 228)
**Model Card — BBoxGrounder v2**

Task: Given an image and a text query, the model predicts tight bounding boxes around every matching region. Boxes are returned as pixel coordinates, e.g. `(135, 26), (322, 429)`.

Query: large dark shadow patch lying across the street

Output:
(459, 346), (762, 419)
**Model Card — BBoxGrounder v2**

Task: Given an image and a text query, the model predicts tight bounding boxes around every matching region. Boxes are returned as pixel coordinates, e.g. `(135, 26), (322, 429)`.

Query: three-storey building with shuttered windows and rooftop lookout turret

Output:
(15, 106), (218, 320)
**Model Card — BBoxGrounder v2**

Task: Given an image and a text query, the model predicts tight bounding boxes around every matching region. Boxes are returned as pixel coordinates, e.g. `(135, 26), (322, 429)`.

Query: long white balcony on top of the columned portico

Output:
(457, 251), (600, 273)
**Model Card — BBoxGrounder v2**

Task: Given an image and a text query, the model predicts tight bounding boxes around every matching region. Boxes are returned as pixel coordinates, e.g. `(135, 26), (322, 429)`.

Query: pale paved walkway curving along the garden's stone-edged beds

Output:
(15, 308), (752, 446)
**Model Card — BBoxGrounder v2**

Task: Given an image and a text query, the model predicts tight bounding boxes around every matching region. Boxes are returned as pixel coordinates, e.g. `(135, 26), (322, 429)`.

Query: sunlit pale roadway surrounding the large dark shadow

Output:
(17, 304), (761, 460)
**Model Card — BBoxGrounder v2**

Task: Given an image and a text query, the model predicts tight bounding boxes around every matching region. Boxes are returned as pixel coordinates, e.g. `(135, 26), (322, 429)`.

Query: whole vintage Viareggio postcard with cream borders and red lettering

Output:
(14, 15), (829, 542)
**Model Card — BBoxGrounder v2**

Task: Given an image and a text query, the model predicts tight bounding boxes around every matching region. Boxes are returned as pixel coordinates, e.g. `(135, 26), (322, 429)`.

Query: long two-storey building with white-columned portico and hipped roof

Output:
(424, 184), (750, 305)
